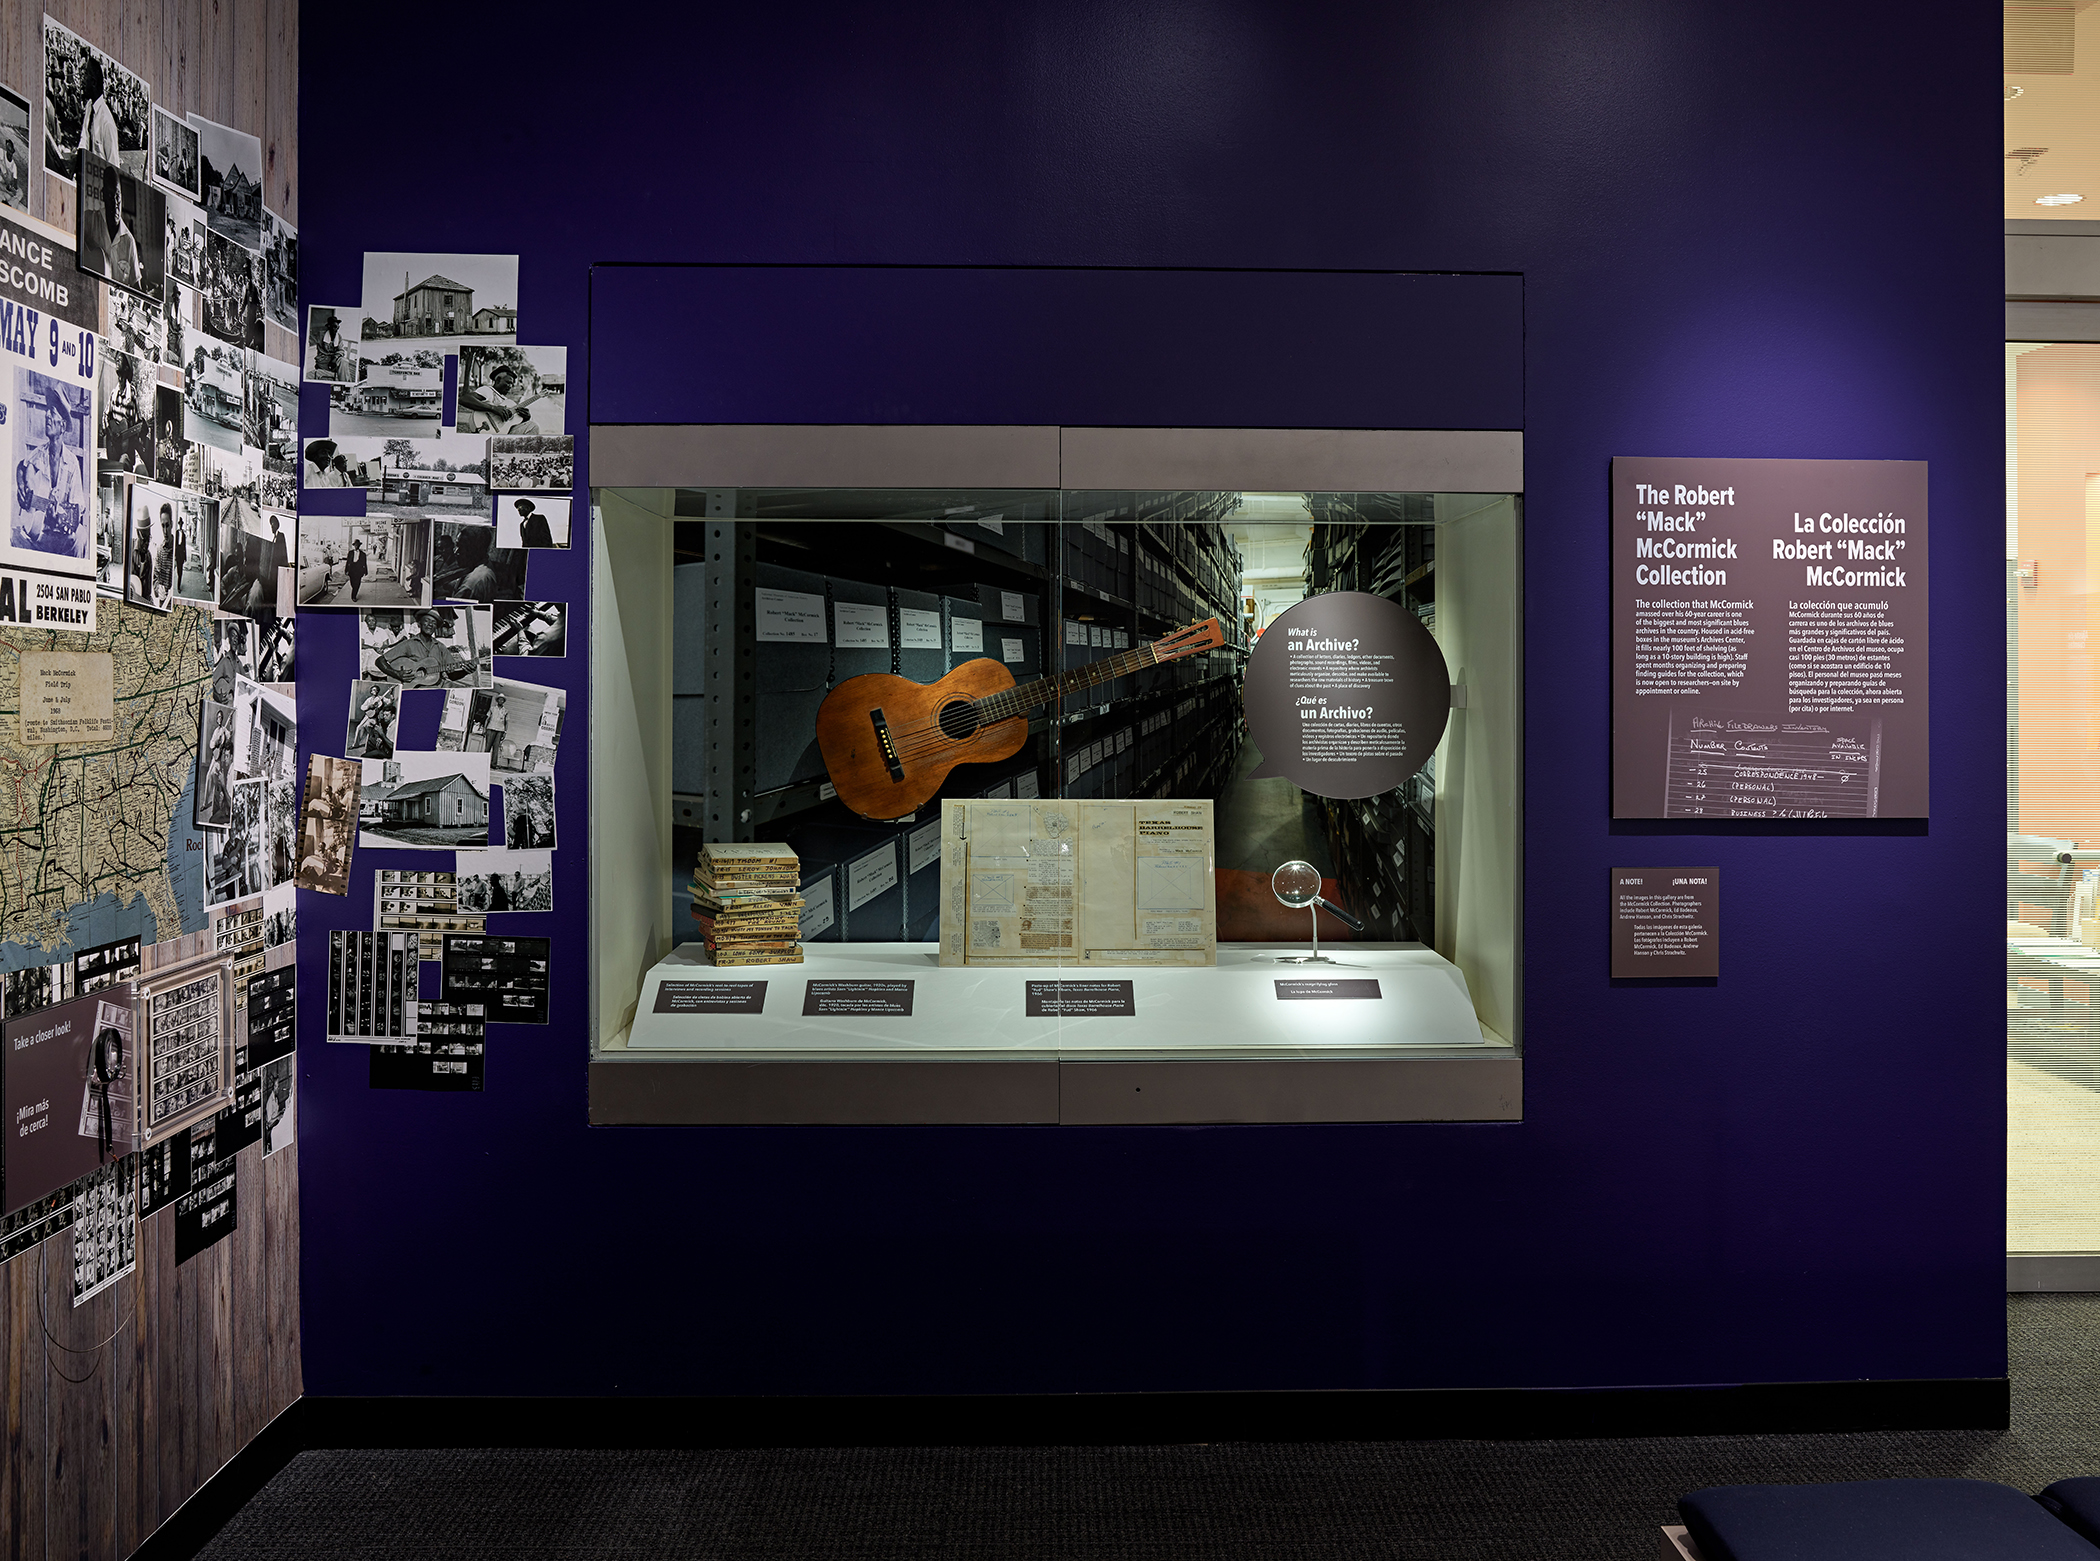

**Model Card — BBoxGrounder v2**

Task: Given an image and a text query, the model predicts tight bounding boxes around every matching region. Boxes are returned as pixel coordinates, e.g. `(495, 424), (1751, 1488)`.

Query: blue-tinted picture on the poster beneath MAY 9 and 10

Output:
(0, 365), (95, 578)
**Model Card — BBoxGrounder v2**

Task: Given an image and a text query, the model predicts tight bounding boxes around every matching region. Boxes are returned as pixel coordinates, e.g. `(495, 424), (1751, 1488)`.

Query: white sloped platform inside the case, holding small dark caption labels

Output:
(626, 943), (1510, 1061)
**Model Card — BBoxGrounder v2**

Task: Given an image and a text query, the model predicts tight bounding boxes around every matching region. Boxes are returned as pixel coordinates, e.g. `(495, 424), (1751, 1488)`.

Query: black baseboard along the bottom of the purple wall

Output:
(302, 1378), (2012, 1448)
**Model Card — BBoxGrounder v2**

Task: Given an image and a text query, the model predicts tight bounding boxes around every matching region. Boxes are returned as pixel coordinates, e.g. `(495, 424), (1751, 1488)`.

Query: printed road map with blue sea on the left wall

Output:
(0, 597), (210, 971)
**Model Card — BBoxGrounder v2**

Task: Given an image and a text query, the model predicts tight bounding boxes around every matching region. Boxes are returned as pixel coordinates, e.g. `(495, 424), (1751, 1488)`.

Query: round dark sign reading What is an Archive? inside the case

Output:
(1243, 590), (1451, 798)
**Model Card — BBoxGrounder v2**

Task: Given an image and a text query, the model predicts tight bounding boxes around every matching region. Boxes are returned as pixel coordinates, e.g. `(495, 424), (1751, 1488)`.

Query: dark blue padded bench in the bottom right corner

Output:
(1663, 1479), (2100, 1561)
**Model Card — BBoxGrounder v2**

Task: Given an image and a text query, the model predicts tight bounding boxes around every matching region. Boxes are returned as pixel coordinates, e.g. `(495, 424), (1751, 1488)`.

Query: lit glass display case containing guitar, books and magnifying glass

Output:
(590, 476), (1523, 1122)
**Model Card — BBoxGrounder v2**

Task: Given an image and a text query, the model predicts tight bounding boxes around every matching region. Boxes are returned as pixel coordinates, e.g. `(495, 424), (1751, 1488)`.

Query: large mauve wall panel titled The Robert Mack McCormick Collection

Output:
(1611, 456), (1930, 819)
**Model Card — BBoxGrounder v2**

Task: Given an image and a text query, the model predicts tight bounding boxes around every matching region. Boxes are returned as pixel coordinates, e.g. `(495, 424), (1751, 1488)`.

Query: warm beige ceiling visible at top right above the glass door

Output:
(2006, 0), (2100, 223)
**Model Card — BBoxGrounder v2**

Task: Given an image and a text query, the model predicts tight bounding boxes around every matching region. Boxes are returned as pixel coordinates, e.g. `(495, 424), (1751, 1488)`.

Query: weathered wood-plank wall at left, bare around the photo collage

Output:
(0, 0), (302, 1561)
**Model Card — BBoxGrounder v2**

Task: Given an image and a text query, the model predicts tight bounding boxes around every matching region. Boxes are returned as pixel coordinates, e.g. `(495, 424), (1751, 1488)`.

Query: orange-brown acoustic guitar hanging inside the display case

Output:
(817, 618), (1224, 819)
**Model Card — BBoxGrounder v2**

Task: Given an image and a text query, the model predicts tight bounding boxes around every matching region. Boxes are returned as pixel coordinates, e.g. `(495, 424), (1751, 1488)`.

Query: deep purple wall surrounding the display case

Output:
(300, 0), (2006, 1393)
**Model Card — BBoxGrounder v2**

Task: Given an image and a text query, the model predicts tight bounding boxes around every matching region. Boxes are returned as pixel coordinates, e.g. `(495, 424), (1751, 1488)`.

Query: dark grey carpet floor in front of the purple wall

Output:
(204, 1296), (2100, 1561)
